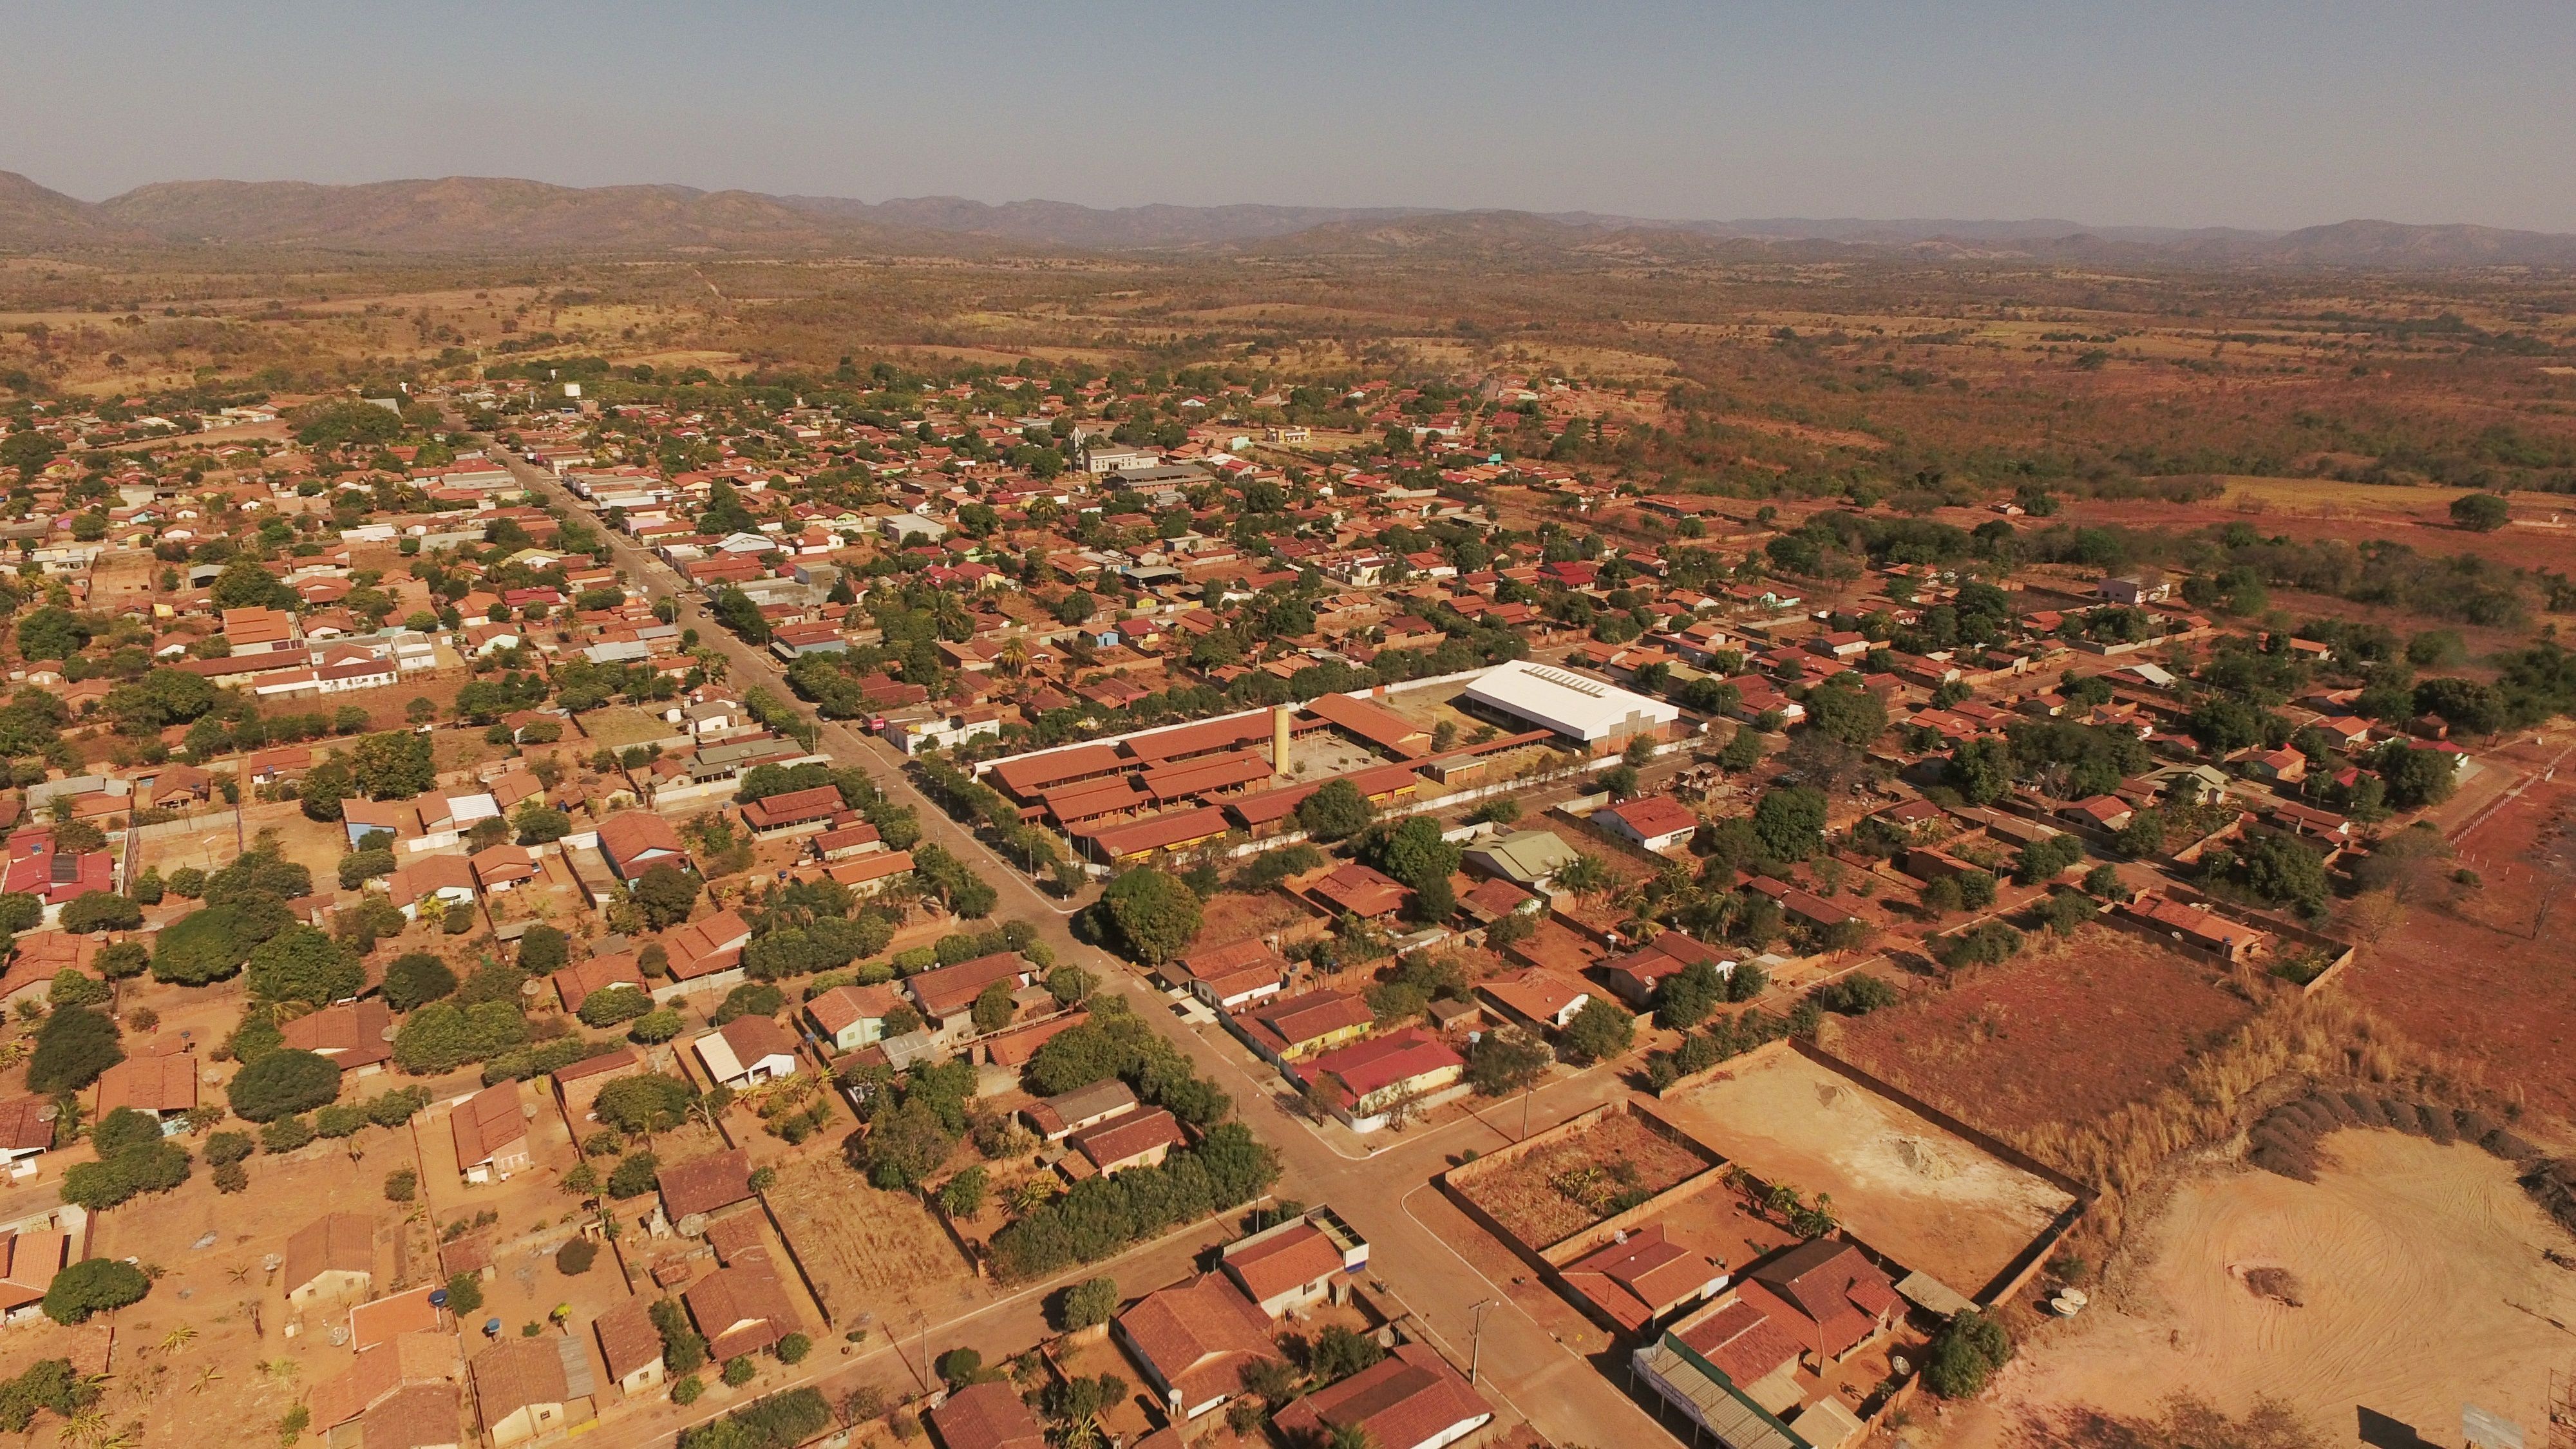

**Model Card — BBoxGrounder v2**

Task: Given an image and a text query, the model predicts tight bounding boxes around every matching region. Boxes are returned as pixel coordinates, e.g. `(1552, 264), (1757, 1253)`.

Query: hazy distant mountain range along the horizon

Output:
(0, 170), (2576, 268)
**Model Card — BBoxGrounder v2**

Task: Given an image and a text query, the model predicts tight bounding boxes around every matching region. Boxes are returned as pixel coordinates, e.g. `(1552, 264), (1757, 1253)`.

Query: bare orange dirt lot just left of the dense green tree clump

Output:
(765, 1153), (989, 1333)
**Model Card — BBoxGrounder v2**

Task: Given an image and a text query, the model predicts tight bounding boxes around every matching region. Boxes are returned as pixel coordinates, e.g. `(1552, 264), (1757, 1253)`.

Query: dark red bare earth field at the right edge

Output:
(2344, 768), (2576, 1135)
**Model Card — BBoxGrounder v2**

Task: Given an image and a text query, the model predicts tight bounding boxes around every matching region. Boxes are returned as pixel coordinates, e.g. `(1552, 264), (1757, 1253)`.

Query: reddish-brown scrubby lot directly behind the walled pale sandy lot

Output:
(1834, 925), (2254, 1135)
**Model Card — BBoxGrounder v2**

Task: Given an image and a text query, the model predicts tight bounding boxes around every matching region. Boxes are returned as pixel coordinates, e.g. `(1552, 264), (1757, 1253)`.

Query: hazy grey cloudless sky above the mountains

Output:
(0, 0), (2576, 229)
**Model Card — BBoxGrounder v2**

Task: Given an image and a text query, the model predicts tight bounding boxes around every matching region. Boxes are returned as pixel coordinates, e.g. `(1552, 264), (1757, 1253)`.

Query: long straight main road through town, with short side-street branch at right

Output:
(487, 439), (1669, 1444)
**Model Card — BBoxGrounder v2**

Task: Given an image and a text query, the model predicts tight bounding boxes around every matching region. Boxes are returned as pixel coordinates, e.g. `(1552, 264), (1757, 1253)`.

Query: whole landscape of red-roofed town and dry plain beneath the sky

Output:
(0, 42), (2576, 1449)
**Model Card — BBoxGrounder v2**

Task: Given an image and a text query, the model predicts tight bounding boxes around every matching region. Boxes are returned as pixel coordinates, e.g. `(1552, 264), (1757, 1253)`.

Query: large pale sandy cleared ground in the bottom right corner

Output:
(1947, 1132), (2576, 1446)
